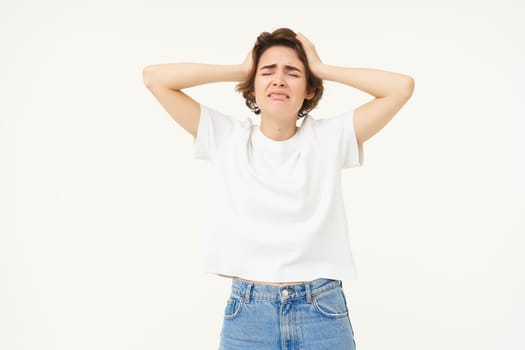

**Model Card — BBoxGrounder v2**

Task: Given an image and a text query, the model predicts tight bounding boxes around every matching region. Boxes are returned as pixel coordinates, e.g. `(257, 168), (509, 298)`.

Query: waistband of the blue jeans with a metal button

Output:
(232, 278), (343, 303)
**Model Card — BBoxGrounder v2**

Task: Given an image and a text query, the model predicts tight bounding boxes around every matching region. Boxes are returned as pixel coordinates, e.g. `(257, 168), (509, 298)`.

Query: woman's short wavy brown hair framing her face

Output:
(236, 28), (324, 119)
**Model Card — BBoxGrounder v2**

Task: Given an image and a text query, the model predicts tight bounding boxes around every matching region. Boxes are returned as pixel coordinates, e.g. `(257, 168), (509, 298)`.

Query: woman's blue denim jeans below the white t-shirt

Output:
(220, 278), (355, 350)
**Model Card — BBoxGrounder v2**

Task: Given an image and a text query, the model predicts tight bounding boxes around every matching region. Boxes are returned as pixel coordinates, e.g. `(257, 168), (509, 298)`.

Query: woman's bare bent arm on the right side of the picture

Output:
(297, 34), (414, 143)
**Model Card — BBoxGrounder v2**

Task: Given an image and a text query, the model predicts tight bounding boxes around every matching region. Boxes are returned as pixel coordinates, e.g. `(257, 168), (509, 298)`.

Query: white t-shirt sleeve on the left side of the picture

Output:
(193, 105), (234, 160)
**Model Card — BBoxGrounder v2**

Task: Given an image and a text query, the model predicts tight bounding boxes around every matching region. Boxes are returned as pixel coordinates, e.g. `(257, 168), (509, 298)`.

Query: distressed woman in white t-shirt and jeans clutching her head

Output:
(144, 28), (414, 350)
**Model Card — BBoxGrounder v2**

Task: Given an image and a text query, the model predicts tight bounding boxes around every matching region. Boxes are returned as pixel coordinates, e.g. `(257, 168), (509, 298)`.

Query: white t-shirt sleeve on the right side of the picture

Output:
(318, 111), (364, 169)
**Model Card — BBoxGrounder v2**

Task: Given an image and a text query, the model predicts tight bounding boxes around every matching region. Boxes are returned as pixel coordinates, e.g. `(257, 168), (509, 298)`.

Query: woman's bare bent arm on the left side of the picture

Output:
(142, 59), (251, 138)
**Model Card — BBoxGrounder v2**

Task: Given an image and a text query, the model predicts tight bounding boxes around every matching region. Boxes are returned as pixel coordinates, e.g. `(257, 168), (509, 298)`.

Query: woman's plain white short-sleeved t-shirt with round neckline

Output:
(193, 105), (363, 282)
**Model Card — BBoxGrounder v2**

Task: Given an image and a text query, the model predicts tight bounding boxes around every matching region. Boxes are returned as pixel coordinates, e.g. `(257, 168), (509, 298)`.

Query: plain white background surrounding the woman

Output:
(0, 0), (525, 350)
